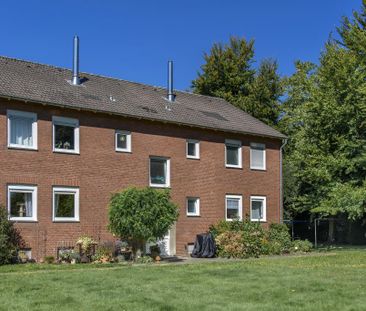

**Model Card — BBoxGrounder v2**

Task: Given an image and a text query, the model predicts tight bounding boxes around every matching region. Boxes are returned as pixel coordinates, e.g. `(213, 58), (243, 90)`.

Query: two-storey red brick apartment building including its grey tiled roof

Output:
(0, 44), (285, 260)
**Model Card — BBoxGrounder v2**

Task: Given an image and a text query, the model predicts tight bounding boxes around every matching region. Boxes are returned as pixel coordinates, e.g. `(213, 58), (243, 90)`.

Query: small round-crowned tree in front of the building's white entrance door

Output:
(109, 188), (179, 259)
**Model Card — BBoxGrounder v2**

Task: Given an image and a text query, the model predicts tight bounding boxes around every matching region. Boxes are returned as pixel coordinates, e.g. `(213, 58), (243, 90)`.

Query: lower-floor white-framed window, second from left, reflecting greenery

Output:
(53, 187), (79, 221)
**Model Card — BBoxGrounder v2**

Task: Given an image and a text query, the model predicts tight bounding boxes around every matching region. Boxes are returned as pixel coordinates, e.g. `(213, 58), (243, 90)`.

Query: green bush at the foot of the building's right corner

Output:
(266, 224), (292, 255)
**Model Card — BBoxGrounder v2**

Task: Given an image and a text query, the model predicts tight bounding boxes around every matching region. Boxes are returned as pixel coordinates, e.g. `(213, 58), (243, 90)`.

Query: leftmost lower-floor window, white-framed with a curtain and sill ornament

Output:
(8, 185), (37, 221)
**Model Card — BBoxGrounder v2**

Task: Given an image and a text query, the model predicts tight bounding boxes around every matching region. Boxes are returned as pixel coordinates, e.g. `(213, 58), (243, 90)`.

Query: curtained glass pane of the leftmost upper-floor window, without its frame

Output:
(10, 117), (33, 147)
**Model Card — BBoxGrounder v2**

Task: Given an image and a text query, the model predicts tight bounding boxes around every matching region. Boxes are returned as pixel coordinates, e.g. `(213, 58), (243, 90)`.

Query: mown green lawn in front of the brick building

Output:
(0, 249), (366, 311)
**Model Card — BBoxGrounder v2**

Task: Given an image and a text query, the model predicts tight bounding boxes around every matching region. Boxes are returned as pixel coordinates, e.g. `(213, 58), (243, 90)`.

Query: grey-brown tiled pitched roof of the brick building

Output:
(0, 57), (285, 138)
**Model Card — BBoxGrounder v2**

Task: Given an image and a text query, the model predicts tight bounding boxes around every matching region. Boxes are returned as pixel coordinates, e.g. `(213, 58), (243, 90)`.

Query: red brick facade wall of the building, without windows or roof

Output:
(0, 100), (281, 259)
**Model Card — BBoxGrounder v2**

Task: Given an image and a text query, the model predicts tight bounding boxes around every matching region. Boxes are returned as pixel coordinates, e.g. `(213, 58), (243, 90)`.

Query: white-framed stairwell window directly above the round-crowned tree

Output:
(150, 157), (170, 187)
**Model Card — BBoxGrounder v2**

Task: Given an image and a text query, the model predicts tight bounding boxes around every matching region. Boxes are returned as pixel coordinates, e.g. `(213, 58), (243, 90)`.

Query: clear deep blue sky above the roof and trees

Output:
(0, 0), (361, 90)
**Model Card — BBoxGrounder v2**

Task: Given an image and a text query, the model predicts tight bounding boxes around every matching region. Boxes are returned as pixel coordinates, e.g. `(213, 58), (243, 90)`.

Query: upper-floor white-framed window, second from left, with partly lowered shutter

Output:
(52, 117), (79, 153)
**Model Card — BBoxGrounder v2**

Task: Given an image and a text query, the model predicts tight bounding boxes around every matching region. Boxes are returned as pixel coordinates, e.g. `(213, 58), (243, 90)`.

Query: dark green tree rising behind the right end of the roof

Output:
(192, 37), (283, 125)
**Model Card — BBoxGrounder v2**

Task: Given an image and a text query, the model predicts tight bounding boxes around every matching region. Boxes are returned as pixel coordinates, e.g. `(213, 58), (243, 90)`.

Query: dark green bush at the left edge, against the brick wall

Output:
(0, 206), (24, 265)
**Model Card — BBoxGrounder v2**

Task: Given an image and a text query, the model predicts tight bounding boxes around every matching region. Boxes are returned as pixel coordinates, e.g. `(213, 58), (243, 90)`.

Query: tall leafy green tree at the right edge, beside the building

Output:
(280, 1), (366, 239)
